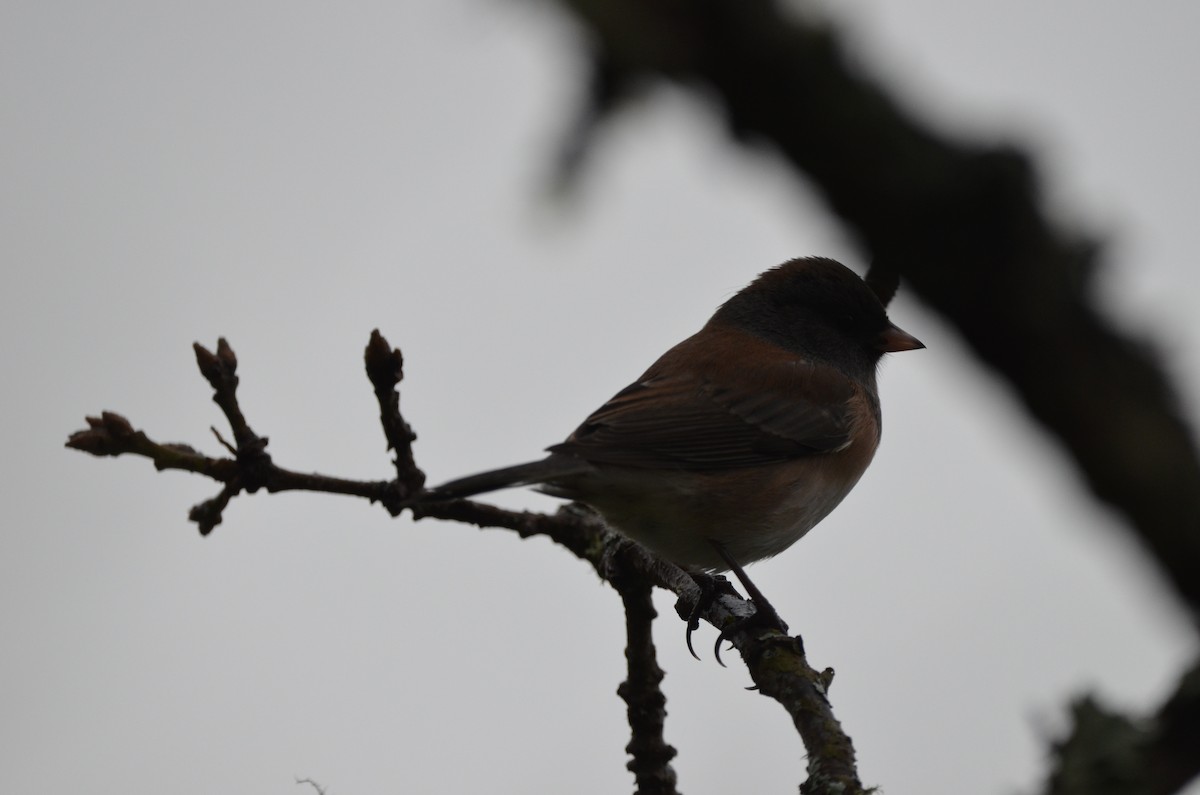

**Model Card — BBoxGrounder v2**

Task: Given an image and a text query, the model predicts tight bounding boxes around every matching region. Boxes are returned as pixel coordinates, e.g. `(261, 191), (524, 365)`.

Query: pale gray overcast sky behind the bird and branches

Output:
(0, 0), (1200, 795)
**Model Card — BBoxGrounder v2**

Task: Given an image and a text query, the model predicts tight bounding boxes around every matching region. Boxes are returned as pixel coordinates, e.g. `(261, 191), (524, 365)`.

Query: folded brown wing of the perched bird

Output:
(548, 343), (862, 471)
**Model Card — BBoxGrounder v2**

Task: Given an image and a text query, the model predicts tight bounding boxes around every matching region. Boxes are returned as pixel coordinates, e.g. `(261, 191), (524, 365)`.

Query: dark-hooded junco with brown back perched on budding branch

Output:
(427, 257), (924, 572)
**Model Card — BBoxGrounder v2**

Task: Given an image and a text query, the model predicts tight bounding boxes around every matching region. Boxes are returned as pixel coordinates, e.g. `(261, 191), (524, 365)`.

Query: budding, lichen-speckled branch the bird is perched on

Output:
(67, 331), (862, 795)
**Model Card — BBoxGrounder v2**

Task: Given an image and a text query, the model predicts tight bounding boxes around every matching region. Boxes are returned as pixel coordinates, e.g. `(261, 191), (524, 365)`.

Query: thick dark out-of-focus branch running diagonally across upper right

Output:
(549, 0), (1200, 622)
